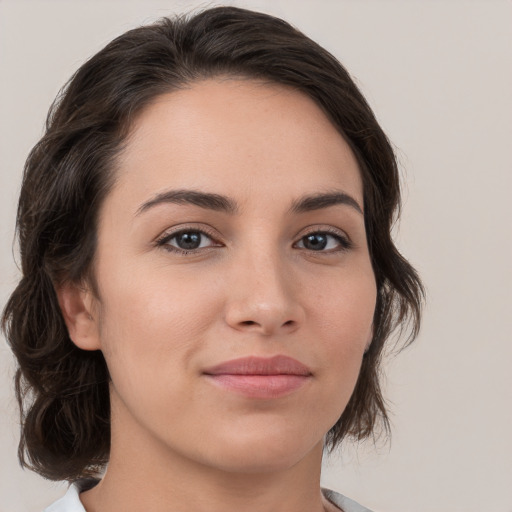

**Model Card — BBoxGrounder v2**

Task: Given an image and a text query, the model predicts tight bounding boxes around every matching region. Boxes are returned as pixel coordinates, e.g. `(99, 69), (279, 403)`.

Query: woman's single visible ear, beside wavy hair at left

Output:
(55, 282), (100, 350)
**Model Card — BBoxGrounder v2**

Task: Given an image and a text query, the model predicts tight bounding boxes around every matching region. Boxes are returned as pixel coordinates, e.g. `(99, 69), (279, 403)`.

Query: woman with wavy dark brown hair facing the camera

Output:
(4, 8), (422, 512)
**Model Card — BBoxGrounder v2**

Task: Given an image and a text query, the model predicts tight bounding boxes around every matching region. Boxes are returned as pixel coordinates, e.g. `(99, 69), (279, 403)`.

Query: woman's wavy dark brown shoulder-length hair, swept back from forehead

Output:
(3, 7), (423, 480)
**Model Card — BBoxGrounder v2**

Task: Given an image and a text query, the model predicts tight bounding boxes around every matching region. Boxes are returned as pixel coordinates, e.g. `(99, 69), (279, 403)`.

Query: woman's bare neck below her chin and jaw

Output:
(80, 400), (326, 512)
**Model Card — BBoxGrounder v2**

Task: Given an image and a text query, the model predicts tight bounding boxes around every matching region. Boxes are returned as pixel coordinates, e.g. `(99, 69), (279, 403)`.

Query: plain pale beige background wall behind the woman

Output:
(0, 0), (512, 512)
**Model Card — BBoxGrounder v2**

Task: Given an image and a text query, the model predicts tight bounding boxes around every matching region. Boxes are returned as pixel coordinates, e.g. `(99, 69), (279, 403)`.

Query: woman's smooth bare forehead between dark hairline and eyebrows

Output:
(114, 78), (362, 208)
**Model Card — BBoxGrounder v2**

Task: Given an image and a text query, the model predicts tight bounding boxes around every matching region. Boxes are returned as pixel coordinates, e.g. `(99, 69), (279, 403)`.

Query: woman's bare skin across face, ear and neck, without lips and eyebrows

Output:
(58, 78), (376, 512)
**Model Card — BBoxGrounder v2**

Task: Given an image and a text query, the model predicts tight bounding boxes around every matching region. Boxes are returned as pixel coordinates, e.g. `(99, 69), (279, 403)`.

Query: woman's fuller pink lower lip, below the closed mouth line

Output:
(203, 374), (310, 399)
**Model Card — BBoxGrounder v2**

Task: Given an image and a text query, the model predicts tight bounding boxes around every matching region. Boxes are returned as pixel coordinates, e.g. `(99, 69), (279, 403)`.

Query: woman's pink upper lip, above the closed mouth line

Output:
(203, 355), (311, 376)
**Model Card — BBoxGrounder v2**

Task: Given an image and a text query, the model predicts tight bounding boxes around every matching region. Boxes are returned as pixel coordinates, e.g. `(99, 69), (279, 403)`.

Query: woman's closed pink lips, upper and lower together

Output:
(203, 355), (313, 399)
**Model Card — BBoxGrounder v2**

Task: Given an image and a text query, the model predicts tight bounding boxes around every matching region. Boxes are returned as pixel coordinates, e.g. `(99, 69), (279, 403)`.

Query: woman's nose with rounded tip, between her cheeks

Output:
(225, 254), (305, 336)
